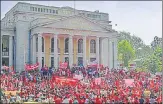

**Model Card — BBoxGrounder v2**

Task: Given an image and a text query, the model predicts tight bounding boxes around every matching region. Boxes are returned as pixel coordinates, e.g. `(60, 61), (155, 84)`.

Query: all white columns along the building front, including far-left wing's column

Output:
(1, 34), (118, 68)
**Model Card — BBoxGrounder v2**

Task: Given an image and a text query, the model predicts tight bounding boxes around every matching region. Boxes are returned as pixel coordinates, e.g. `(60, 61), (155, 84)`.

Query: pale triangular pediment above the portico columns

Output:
(43, 16), (112, 32)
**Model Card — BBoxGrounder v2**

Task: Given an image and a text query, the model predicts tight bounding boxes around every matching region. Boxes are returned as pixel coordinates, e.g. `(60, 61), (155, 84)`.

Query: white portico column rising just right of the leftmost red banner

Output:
(37, 34), (42, 69)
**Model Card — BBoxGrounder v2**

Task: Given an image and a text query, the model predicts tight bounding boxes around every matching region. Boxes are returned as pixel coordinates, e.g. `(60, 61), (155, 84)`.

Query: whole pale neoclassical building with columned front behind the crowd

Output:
(1, 2), (118, 71)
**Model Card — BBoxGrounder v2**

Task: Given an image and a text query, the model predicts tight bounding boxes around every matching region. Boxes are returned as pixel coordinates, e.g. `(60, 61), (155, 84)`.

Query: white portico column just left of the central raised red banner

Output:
(54, 34), (58, 68)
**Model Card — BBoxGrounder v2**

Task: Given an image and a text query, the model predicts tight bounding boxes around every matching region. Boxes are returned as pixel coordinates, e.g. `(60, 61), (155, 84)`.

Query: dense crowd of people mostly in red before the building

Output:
(0, 67), (162, 104)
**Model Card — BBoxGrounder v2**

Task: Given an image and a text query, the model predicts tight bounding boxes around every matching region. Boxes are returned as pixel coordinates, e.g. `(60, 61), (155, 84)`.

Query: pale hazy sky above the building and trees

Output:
(1, 1), (162, 45)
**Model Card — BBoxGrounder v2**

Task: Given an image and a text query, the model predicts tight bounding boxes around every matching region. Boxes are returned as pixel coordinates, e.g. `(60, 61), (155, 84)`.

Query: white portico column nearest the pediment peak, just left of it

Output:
(69, 35), (73, 68)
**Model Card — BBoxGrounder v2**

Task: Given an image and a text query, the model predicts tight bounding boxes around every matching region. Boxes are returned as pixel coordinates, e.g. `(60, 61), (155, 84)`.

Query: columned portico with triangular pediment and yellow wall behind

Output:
(32, 17), (117, 68)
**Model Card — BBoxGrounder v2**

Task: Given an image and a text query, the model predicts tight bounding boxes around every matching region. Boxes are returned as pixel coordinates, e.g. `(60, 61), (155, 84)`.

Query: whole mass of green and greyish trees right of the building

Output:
(118, 31), (162, 73)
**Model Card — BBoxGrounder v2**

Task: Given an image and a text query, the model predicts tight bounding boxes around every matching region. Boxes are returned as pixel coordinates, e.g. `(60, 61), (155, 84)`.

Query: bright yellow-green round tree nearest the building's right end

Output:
(118, 40), (135, 67)
